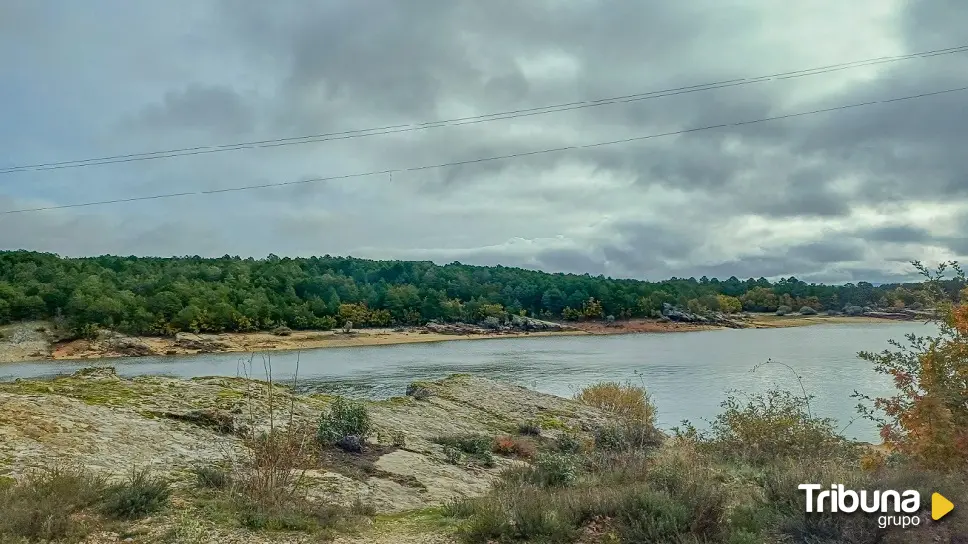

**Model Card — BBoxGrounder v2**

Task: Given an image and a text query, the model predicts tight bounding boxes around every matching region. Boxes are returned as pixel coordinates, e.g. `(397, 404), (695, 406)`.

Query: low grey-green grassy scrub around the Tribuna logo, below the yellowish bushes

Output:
(454, 441), (968, 544)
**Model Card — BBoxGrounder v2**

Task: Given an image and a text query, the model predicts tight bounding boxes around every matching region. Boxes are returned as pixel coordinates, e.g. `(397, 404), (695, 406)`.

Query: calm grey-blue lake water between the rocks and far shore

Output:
(0, 322), (937, 442)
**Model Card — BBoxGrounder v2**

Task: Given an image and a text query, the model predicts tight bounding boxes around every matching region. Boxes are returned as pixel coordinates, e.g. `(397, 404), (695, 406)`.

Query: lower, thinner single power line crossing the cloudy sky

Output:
(0, 86), (968, 215)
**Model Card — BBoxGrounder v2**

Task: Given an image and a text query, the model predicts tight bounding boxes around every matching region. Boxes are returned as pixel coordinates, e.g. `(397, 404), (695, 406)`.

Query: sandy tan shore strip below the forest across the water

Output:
(0, 314), (908, 363)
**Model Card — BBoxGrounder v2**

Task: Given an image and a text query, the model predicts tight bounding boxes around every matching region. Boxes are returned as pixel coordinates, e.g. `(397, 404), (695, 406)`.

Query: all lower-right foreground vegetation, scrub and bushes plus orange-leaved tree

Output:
(445, 263), (968, 544)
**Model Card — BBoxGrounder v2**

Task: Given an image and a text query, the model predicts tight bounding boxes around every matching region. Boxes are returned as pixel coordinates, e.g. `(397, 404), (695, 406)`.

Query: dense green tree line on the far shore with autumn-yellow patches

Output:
(0, 251), (961, 334)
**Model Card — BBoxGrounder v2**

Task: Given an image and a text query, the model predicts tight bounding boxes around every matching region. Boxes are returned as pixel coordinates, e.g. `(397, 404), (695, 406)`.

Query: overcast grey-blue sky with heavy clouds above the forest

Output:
(0, 0), (968, 282)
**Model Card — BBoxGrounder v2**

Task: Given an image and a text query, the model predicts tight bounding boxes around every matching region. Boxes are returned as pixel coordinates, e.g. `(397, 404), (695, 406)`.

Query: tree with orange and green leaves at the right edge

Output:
(854, 261), (968, 470)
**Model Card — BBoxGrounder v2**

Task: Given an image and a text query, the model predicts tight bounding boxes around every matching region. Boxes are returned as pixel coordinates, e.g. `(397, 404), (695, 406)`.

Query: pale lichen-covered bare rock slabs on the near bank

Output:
(0, 367), (607, 513)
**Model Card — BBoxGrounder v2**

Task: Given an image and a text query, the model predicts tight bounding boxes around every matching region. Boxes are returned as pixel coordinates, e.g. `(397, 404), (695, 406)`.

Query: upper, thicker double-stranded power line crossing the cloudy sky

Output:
(0, 44), (968, 175)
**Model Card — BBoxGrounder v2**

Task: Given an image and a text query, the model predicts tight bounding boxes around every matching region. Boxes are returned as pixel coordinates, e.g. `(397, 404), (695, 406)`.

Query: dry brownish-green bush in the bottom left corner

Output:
(0, 467), (105, 542)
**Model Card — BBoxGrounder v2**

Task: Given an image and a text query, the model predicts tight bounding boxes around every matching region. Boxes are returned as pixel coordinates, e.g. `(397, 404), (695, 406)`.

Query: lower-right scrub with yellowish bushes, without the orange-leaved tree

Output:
(443, 386), (968, 544)
